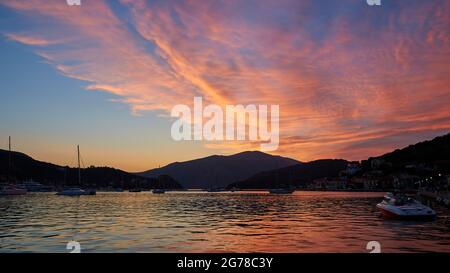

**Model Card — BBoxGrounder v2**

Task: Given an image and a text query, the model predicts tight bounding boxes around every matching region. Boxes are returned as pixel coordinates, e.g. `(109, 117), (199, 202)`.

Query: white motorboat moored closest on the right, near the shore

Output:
(377, 193), (436, 220)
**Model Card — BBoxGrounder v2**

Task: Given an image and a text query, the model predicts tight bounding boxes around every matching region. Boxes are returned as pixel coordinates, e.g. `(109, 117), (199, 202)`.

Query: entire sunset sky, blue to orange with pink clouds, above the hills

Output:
(0, 0), (450, 171)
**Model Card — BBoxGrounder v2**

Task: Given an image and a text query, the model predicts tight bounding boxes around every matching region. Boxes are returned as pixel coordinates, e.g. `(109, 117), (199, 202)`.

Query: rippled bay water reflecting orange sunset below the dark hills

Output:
(0, 192), (450, 252)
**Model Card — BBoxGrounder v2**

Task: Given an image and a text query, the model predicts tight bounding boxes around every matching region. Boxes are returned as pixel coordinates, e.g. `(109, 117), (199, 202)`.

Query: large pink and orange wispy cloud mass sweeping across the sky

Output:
(2, 0), (450, 160)
